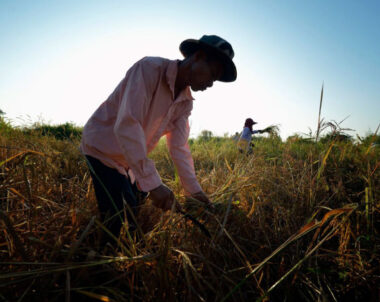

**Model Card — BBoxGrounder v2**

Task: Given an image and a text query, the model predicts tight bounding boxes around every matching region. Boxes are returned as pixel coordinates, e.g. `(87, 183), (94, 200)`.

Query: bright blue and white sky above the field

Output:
(0, 0), (380, 138)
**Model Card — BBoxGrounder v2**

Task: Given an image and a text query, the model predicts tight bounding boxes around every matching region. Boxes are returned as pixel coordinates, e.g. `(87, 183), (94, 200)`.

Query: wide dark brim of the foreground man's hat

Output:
(179, 39), (237, 82)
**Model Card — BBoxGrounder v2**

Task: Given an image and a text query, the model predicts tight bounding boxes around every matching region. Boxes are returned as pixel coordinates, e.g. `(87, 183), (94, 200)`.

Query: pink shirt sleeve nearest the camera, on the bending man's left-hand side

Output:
(114, 61), (162, 192)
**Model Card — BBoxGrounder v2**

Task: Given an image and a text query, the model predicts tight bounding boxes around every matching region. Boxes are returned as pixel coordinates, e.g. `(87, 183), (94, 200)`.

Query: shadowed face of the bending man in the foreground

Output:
(189, 56), (223, 91)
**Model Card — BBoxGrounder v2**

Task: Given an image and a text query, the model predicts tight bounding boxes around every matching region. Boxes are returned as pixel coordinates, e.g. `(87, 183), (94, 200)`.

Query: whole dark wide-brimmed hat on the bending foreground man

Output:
(179, 35), (236, 82)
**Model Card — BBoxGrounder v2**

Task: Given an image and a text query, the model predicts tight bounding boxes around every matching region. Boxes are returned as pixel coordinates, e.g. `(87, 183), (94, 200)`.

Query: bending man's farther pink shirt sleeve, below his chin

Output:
(166, 113), (202, 194)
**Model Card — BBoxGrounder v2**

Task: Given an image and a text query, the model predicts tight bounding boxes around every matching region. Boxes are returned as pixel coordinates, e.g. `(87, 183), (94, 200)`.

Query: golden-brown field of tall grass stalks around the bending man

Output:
(0, 121), (380, 301)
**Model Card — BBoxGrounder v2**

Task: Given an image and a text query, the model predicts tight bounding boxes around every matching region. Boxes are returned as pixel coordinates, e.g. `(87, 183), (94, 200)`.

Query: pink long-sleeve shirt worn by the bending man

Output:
(81, 57), (201, 194)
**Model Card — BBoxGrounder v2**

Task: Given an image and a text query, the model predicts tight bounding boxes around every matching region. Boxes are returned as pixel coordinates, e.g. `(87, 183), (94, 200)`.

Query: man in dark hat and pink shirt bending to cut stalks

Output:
(81, 35), (236, 236)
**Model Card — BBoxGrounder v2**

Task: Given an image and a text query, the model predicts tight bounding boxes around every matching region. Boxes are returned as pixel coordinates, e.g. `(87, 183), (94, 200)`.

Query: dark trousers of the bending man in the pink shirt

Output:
(86, 155), (147, 238)
